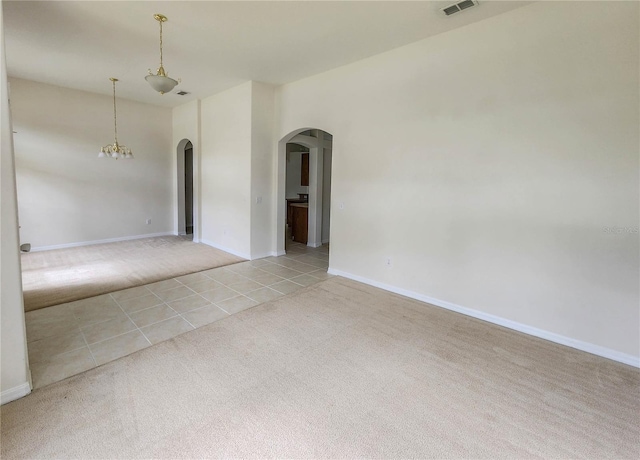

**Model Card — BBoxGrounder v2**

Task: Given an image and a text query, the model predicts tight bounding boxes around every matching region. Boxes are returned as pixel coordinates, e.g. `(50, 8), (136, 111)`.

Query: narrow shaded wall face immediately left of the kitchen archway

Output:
(251, 82), (276, 259)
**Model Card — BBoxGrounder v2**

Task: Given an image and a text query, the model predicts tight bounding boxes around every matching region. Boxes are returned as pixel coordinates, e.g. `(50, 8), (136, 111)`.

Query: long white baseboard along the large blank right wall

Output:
(328, 268), (640, 368)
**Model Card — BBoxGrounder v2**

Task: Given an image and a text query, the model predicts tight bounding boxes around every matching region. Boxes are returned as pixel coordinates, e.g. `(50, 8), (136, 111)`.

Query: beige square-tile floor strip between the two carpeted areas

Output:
(26, 243), (330, 388)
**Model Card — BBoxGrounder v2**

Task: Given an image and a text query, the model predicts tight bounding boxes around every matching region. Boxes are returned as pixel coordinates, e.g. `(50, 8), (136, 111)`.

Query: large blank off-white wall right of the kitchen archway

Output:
(276, 2), (640, 365)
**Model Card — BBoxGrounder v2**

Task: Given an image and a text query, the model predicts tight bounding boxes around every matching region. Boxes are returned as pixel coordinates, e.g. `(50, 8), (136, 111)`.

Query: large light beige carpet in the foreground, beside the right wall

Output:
(1, 277), (640, 459)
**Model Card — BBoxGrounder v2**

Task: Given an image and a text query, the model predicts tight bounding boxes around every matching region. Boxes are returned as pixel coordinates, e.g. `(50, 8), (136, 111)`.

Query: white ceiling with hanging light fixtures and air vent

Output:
(2, 0), (530, 107)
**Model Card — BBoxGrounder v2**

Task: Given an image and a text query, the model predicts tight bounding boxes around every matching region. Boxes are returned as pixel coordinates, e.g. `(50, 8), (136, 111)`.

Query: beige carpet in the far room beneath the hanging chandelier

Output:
(21, 236), (244, 311)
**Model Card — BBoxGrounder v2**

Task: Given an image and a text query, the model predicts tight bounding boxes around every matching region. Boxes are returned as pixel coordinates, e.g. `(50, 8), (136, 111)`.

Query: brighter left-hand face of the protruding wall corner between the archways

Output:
(201, 82), (252, 258)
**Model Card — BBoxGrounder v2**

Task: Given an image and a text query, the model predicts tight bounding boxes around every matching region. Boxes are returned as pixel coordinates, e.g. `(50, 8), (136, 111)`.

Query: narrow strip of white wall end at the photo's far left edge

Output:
(0, 8), (31, 404)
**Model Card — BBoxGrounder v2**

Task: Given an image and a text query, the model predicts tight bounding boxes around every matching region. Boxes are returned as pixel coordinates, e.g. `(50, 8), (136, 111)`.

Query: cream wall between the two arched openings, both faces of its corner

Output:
(180, 82), (274, 259)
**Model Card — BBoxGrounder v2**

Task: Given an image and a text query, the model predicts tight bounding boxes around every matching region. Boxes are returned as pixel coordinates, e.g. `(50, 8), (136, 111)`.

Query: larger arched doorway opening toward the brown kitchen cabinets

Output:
(275, 128), (333, 255)
